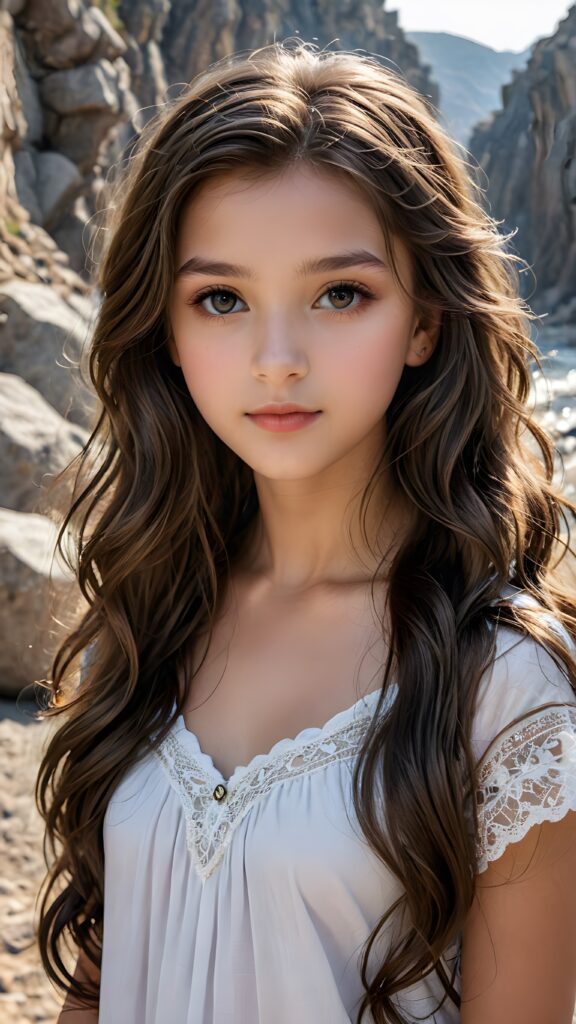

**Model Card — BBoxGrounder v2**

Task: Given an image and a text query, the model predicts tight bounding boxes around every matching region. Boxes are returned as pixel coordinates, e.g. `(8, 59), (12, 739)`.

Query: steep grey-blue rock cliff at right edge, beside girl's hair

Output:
(469, 5), (576, 323)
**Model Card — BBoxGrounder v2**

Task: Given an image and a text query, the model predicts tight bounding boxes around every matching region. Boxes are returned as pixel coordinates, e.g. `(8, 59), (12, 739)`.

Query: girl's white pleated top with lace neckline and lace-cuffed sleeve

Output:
(98, 598), (576, 1024)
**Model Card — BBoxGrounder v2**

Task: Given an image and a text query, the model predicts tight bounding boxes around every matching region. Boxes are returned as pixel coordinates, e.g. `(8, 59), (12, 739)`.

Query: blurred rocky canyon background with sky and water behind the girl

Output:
(0, 0), (576, 1024)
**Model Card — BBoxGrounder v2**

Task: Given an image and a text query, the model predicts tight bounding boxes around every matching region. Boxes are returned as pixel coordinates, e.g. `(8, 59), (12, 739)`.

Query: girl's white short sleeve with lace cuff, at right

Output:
(472, 610), (576, 872)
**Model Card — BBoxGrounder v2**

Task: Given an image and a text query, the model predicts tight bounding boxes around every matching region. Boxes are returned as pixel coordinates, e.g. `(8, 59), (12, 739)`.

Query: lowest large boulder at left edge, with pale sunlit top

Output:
(0, 509), (77, 696)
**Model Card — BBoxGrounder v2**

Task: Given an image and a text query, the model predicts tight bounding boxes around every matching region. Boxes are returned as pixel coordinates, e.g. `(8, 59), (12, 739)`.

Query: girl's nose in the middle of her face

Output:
(251, 314), (308, 384)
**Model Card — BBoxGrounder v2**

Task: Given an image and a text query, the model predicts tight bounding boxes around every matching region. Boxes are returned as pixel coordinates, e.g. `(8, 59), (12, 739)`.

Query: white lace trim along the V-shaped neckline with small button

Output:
(154, 690), (394, 882)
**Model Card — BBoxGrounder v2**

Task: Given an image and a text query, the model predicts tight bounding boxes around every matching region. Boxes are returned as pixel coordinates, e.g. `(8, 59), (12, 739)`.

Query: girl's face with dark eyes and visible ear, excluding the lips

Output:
(168, 165), (436, 480)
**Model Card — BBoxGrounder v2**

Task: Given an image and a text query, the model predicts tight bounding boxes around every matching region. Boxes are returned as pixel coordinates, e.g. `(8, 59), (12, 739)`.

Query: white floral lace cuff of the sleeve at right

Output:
(477, 705), (576, 871)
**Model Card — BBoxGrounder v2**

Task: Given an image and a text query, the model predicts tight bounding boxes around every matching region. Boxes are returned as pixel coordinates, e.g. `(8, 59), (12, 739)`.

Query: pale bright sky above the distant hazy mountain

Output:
(384, 0), (571, 52)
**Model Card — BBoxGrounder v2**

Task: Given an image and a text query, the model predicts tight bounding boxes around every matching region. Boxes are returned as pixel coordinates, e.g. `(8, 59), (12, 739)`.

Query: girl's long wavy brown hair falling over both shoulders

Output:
(36, 39), (576, 1024)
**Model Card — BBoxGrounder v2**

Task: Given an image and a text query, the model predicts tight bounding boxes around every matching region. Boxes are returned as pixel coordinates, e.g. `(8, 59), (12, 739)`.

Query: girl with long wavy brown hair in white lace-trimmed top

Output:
(37, 40), (576, 1024)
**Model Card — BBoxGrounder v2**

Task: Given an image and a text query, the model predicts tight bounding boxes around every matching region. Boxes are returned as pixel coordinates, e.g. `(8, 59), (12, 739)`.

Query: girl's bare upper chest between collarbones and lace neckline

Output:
(178, 588), (386, 778)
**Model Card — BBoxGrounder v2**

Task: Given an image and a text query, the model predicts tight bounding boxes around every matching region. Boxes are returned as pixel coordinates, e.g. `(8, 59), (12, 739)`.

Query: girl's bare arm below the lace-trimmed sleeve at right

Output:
(460, 811), (576, 1024)
